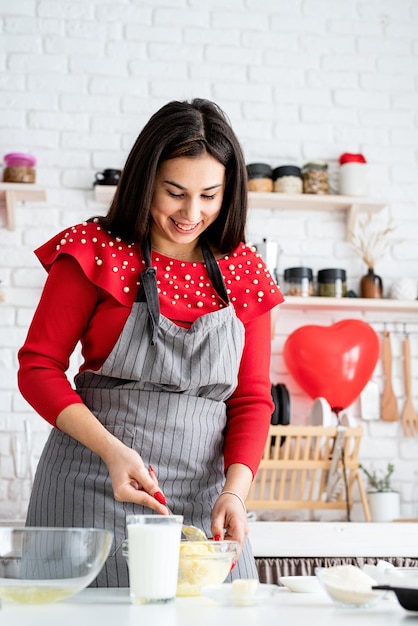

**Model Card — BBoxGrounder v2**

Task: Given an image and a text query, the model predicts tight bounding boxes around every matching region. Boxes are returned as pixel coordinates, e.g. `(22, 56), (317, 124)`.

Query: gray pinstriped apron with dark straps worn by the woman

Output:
(26, 239), (257, 587)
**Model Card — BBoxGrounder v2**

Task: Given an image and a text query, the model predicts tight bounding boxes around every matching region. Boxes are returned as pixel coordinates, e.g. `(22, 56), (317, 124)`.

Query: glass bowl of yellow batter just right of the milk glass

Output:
(122, 539), (238, 596)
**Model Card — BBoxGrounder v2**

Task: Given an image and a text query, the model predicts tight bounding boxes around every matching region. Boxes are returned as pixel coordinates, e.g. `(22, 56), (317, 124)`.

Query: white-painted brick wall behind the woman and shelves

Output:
(0, 0), (418, 518)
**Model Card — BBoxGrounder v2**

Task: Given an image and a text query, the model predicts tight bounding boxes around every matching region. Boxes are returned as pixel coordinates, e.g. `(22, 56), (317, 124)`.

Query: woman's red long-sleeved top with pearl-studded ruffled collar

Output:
(19, 222), (283, 474)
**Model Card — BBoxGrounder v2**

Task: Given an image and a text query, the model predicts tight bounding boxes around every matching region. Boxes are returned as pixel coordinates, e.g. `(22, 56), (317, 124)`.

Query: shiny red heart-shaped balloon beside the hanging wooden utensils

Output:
(283, 319), (380, 413)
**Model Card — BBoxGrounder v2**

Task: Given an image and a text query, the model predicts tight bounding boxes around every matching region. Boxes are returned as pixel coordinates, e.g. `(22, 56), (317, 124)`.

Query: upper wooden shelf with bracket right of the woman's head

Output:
(248, 191), (387, 239)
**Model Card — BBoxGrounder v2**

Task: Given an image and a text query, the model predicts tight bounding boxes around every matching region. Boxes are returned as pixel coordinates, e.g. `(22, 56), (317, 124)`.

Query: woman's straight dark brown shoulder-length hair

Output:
(99, 98), (247, 253)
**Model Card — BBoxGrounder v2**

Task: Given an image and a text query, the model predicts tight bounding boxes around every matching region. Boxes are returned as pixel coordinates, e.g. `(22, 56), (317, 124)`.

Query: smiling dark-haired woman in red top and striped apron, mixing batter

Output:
(19, 99), (283, 586)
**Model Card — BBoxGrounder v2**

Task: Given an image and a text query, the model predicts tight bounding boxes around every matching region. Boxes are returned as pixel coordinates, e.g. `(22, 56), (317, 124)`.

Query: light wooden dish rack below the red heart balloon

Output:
(246, 426), (371, 522)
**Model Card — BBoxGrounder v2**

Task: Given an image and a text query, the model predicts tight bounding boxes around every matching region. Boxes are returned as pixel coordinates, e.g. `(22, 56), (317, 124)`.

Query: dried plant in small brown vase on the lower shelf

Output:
(351, 213), (395, 298)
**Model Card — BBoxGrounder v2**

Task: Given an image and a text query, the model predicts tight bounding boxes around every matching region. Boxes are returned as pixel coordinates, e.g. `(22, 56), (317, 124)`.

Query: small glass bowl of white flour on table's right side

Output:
(315, 565), (385, 609)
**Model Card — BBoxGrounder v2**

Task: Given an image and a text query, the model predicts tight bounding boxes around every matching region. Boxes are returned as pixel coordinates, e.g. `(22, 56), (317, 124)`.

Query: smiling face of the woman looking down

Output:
(151, 154), (225, 253)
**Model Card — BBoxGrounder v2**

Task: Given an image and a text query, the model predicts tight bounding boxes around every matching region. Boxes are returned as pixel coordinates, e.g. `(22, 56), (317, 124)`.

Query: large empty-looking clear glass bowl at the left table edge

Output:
(0, 527), (113, 604)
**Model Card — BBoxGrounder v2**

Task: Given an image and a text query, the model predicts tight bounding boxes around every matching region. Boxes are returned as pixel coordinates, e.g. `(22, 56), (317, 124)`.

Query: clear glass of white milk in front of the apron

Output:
(126, 515), (183, 604)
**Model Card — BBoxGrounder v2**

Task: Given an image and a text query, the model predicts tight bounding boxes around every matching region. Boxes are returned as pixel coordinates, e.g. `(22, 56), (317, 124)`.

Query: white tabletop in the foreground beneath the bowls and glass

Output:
(0, 588), (412, 626)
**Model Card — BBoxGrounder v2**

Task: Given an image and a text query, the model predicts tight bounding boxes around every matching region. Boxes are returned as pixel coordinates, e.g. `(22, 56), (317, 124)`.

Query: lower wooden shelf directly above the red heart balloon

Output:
(280, 296), (418, 313)
